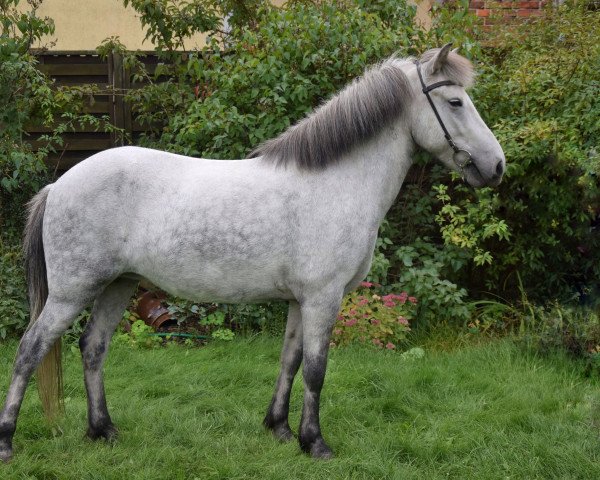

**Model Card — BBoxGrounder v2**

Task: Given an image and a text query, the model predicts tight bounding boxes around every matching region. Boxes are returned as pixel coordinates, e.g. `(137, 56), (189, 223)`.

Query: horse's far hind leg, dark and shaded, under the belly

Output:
(79, 279), (137, 440)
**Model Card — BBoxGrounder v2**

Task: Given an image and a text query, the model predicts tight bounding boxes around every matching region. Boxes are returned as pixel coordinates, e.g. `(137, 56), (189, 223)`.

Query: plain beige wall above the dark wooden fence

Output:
(21, 0), (434, 51)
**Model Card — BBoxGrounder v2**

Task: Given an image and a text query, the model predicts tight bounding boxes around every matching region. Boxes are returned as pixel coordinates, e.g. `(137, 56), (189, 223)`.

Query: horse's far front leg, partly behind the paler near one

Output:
(263, 301), (302, 441)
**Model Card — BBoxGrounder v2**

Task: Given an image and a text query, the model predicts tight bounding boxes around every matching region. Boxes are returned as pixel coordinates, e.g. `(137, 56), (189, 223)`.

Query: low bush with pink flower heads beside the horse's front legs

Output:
(332, 282), (417, 350)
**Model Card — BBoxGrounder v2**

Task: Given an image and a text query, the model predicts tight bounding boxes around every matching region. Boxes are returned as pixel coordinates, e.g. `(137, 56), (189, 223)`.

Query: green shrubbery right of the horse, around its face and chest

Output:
(372, 3), (600, 310)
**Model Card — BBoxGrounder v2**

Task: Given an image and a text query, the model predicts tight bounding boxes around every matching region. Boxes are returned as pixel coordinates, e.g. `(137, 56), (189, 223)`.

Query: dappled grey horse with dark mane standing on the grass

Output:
(0, 45), (505, 461)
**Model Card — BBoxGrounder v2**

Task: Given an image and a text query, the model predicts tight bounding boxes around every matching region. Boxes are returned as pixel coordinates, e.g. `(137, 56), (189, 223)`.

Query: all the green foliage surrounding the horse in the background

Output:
(0, 0), (600, 352)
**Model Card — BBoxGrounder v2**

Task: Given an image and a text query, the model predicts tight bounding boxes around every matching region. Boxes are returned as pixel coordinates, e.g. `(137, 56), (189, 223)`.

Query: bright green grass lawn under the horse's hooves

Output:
(0, 337), (600, 480)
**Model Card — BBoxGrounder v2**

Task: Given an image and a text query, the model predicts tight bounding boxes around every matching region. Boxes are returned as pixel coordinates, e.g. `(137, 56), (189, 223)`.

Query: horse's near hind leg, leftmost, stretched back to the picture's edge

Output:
(0, 296), (85, 461)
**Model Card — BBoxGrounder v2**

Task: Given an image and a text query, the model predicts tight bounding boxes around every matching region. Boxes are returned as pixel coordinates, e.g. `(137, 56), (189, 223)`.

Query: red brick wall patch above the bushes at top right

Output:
(469, 0), (548, 30)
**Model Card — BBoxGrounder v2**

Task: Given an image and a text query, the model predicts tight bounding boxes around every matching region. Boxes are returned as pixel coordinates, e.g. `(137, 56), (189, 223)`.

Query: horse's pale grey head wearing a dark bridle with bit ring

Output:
(407, 44), (506, 187)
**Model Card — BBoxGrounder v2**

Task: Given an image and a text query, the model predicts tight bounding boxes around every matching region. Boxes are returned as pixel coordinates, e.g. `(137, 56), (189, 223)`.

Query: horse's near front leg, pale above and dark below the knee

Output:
(299, 291), (342, 458)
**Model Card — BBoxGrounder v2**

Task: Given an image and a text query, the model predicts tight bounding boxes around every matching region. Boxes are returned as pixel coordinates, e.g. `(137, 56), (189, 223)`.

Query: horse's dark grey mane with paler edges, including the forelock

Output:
(249, 49), (473, 170)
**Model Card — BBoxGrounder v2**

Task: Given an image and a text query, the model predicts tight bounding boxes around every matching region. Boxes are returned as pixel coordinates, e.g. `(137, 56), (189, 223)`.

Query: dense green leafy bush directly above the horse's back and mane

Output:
(113, 0), (416, 158)
